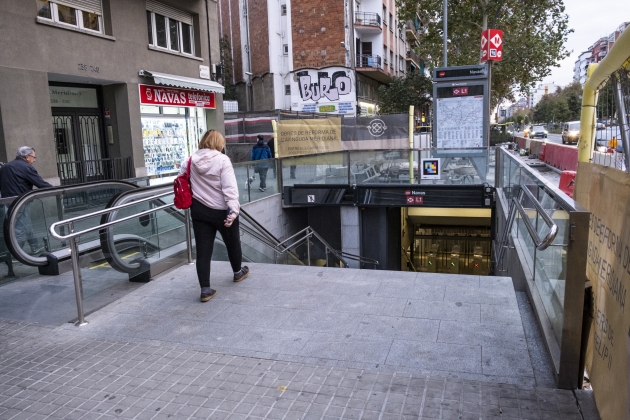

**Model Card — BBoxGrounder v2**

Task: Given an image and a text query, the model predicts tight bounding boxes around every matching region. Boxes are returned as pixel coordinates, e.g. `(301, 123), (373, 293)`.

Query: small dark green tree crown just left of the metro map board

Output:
(378, 73), (433, 114)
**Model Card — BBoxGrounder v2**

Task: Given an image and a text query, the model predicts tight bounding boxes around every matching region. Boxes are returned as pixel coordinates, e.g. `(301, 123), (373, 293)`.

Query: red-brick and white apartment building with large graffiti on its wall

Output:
(218, 0), (420, 115)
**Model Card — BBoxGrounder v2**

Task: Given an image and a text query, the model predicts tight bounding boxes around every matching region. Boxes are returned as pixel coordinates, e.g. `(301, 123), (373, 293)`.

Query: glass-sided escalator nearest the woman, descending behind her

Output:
(95, 185), (362, 281)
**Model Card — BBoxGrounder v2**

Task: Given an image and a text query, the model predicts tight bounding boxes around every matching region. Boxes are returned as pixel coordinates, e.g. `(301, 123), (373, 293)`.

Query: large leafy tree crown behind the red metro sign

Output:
(396, 0), (573, 108)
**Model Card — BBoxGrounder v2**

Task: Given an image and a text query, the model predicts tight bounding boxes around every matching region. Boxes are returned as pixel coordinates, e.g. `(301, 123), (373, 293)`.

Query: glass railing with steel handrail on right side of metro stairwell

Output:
(494, 149), (589, 380)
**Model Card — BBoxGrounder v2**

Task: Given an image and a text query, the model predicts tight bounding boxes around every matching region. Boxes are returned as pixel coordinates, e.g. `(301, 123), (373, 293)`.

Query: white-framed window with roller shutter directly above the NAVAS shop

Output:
(147, 6), (194, 55)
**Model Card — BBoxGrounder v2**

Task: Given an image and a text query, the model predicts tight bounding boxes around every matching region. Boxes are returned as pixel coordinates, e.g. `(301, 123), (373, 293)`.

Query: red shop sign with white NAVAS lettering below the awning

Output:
(140, 85), (216, 109)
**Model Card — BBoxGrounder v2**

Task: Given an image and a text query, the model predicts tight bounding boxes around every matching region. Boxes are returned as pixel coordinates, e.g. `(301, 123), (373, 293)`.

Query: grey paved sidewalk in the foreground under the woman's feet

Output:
(0, 262), (594, 420)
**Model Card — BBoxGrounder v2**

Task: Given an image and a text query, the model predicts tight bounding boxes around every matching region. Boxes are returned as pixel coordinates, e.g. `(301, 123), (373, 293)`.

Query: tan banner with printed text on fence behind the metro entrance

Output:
(278, 117), (341, 158)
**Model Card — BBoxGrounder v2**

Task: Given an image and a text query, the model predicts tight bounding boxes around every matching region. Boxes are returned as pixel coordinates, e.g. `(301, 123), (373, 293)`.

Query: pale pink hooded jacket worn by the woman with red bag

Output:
(180, 149), (241, 216)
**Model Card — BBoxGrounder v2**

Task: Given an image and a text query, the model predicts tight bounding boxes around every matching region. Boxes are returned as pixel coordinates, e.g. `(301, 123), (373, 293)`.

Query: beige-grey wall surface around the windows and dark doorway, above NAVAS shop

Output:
(0, 0), (222, 183)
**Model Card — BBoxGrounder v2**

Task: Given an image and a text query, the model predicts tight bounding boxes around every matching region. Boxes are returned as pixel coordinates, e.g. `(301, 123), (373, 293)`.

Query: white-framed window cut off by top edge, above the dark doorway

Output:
(36, 0), (103, 33)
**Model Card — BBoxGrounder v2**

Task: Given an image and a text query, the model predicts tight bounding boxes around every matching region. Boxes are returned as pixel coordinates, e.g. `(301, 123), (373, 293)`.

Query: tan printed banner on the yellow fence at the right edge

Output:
(574, 162), (630, 420)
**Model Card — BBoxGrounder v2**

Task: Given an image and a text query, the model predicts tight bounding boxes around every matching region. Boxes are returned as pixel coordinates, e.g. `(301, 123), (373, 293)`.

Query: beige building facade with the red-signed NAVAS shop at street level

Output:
(0, 0), (223, 185)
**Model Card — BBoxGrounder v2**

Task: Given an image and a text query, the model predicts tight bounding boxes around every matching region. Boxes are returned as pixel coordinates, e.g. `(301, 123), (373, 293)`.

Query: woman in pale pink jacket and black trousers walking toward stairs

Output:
(182, 130), (249, 302)
